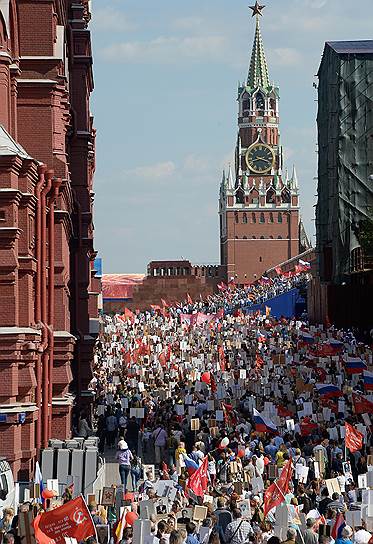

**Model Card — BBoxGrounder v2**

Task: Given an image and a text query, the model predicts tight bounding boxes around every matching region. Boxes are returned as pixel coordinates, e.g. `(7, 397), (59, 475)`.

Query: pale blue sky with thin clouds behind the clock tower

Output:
(91, 0), (372, 273)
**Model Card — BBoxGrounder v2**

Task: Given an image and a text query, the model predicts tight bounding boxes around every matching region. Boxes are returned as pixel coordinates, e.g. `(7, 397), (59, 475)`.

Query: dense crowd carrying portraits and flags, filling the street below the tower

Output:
(83, 270), (373, 544)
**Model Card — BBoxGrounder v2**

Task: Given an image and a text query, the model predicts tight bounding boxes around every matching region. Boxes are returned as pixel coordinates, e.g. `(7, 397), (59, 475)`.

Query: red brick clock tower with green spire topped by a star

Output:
(219, 3), (300, 284)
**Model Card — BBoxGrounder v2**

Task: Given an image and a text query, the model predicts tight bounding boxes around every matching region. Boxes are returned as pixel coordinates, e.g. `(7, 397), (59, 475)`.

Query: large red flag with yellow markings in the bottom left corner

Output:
(32, 497), (96, 544)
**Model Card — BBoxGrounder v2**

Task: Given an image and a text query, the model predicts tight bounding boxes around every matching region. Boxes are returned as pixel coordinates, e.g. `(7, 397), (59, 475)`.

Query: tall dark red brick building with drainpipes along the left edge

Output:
(0, 0), (100, 479)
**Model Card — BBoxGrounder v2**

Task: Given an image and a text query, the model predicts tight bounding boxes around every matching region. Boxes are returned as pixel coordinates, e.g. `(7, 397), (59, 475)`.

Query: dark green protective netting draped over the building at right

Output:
(316, 44), (373, 282)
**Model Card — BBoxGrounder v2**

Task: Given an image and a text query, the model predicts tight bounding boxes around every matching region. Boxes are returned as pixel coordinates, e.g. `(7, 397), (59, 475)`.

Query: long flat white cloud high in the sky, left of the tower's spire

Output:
(101, 36), (225, 63)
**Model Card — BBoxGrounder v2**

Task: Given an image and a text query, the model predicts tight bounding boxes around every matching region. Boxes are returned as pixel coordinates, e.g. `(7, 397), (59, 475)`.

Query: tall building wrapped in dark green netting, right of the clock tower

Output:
(313, 40), (373, 328)
